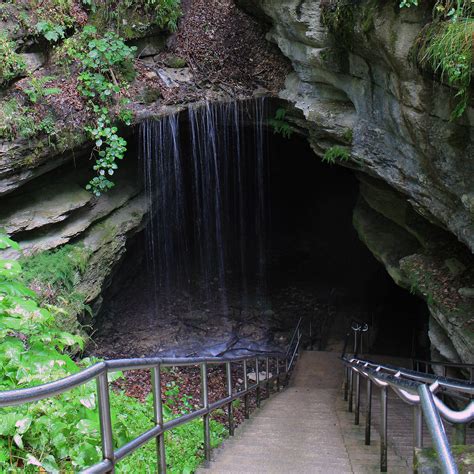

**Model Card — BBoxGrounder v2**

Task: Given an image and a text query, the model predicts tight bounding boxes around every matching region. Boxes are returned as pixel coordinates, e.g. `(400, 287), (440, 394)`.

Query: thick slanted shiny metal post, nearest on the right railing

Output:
(418, 384), (458, 474)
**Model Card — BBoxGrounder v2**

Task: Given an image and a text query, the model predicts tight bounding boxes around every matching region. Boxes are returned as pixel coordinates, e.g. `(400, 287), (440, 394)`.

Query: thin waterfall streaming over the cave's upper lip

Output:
(140, 98), (269, 307)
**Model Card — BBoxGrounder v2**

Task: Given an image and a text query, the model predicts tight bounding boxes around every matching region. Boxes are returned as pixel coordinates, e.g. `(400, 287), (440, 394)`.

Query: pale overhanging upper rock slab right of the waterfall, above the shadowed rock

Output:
(248, 0), (474, 250)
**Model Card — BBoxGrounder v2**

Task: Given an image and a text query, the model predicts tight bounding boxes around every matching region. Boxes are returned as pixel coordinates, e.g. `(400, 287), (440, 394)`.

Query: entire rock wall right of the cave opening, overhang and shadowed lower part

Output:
(239, 0), (474, 362)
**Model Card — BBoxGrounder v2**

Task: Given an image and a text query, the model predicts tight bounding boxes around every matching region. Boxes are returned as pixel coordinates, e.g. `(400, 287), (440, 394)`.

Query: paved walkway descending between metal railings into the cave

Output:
(200, 352), (410, 474)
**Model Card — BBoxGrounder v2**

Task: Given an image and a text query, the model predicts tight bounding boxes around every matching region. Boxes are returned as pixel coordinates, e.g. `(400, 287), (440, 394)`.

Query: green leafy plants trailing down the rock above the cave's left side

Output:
(0, 0), (181, 196)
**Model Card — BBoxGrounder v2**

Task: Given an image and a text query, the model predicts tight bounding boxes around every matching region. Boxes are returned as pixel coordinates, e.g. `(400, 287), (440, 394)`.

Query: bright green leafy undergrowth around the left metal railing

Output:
(0, 235), (225, 473)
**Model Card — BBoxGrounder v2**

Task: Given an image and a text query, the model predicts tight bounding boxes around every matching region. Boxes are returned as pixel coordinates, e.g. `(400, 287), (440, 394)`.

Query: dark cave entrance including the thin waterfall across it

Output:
(92, 102), (427, 357)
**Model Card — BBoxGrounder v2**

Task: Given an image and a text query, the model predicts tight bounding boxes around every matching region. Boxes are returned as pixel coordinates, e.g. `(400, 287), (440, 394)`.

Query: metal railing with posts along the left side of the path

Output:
(0, 318), (301, 474)
